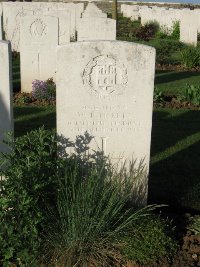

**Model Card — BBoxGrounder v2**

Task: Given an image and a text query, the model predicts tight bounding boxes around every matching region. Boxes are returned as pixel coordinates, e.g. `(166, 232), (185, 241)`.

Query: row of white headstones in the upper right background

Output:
(121, 4), (200, 46)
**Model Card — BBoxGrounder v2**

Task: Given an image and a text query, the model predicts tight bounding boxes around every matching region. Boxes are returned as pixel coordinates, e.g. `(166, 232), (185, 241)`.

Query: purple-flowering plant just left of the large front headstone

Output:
(32, 78), (56, 101)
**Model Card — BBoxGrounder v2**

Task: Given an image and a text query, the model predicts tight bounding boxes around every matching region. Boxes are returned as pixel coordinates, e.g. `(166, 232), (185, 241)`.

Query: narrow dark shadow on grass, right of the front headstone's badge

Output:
(155, 71), (200, 84)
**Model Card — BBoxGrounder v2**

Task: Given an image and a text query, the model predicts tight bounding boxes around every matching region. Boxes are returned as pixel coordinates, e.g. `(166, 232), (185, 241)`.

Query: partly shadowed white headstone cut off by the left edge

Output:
(0, 41), (14, 152)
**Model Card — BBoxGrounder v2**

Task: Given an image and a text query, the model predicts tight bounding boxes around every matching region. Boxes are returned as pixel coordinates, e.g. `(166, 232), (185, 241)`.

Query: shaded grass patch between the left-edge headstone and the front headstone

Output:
(14, 106), (56, 137)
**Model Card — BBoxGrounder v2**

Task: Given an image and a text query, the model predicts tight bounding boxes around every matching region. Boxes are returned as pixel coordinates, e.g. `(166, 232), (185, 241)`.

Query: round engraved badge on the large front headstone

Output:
(83, 55), (128, 97)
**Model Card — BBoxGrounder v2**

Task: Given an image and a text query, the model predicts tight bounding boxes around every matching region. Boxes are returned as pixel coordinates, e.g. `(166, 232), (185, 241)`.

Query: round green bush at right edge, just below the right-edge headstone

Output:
(180, 45), (200, 69)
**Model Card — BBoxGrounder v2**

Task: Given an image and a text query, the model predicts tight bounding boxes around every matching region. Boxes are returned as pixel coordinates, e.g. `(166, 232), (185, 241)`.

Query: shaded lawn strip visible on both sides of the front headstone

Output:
(14, 105), (200, 211)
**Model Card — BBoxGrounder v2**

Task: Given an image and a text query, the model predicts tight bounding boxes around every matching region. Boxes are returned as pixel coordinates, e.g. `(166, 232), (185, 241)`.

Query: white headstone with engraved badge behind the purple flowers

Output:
(20, 16), (58, 92)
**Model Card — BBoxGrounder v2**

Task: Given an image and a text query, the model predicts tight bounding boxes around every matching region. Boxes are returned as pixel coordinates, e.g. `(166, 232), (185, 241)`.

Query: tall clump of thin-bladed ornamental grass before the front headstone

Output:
(42, 157), (159, 267)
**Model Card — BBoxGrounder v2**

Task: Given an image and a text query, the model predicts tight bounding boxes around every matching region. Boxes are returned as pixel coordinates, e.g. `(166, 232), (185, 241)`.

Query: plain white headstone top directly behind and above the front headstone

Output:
(77, 18), (116, 41)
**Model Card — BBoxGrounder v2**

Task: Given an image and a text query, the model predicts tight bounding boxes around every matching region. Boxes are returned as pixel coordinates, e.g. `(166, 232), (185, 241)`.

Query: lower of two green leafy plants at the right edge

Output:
(178, 84), (200, 106)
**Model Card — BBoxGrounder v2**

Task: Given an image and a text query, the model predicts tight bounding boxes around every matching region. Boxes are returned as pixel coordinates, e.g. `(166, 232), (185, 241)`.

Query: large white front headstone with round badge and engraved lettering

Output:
(56, 41), (155, 203)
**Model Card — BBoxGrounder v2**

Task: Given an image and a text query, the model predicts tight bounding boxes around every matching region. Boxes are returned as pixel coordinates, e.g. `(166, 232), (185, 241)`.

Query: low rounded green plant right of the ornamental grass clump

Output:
(123, 215), (178, 264)
